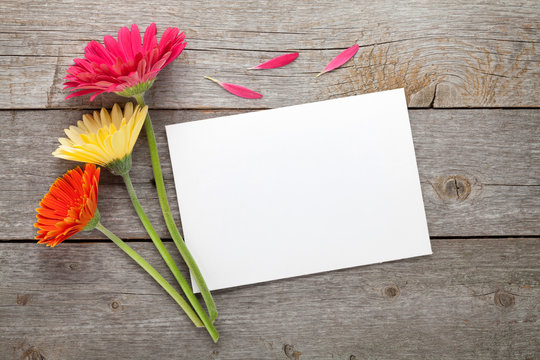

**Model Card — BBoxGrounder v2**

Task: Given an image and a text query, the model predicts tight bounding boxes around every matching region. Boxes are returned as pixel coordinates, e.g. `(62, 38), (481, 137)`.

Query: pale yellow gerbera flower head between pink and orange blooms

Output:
(53, 102), (148, 175)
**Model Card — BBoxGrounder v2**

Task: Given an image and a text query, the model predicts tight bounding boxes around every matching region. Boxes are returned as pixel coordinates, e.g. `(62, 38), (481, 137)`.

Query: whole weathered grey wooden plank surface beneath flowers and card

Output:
(0, 0), (540, 360)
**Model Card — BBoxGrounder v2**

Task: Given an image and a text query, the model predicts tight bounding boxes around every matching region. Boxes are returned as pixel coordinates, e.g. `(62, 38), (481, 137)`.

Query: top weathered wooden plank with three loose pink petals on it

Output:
(0, 0), (540, 109)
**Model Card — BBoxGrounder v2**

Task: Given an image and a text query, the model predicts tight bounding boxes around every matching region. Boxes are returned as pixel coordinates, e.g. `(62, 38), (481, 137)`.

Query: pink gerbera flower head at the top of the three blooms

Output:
(64, 23), (186, 100)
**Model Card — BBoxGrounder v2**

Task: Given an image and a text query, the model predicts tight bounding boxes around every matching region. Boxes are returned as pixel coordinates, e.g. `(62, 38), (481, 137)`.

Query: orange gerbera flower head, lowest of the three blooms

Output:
(34, 164), (99, 246)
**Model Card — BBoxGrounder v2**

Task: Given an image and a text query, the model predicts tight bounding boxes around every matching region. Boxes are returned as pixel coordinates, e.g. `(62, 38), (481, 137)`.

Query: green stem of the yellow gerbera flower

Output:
(122, 172), (219, 342)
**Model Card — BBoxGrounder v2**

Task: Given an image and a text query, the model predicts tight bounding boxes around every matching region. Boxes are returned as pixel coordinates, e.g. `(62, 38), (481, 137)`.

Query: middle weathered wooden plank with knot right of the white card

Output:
(0, 110), (540, 240)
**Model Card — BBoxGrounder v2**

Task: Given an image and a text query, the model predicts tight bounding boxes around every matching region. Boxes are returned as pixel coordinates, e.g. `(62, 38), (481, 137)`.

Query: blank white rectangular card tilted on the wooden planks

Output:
(166, 89), (431, 291)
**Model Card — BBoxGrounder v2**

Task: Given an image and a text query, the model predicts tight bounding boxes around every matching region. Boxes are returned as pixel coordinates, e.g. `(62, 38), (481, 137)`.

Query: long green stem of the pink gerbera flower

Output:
(135, 95), (217, 321)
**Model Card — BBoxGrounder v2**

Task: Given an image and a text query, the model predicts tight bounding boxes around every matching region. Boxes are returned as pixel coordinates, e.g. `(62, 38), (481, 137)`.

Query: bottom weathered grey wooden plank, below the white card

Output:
(0, 239), (540, 360)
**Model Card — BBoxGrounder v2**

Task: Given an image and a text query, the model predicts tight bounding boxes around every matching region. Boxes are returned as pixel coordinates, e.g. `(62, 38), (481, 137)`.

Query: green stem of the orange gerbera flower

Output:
(95, 222), (202, 327)
